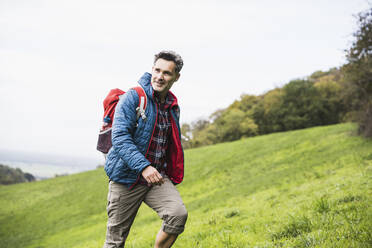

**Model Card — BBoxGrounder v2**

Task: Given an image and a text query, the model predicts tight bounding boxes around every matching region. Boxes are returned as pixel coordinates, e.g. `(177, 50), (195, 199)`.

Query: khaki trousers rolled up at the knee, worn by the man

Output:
(104, 177), (187, 248)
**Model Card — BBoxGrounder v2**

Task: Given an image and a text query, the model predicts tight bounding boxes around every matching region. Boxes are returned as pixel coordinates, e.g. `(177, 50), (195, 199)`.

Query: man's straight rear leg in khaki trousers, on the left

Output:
(104, 181), (149, 248)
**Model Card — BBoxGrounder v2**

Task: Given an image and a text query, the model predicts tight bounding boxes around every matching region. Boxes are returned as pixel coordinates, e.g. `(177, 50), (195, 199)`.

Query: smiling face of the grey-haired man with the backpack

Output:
(151, 59), (180, 97)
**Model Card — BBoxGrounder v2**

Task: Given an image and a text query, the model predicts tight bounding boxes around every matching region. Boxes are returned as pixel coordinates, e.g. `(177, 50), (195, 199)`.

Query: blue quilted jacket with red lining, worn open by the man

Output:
(105, 73), (184, 187)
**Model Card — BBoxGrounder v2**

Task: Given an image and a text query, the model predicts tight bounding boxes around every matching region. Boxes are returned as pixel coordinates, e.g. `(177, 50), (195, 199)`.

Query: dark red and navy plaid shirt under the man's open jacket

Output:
(140, 93), (173, 184)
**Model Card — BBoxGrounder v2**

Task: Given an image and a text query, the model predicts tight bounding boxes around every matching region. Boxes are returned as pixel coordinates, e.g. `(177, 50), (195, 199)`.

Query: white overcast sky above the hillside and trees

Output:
(0, 0), (369, 162)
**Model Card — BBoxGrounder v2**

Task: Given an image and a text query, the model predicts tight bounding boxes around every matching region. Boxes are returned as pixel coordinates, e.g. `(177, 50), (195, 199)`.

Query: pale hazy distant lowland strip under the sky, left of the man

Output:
(0, 150), (103, 179)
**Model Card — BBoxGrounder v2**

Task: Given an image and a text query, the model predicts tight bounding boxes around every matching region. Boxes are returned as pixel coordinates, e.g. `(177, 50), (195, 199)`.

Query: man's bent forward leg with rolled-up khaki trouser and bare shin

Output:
(144, 177), (187, 248)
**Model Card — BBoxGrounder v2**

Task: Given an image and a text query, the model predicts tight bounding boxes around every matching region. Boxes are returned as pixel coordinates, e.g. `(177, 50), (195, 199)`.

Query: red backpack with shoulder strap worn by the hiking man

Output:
(97, 86), (147, 154)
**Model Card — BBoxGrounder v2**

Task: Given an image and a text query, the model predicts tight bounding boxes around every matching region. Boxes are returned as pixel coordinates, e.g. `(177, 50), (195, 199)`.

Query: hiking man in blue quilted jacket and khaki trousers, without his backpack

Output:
(104, 51), (187, 248)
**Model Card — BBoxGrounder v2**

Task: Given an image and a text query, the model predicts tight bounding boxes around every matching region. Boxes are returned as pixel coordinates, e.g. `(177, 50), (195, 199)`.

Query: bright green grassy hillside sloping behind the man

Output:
(0, 124), (372, 248)
